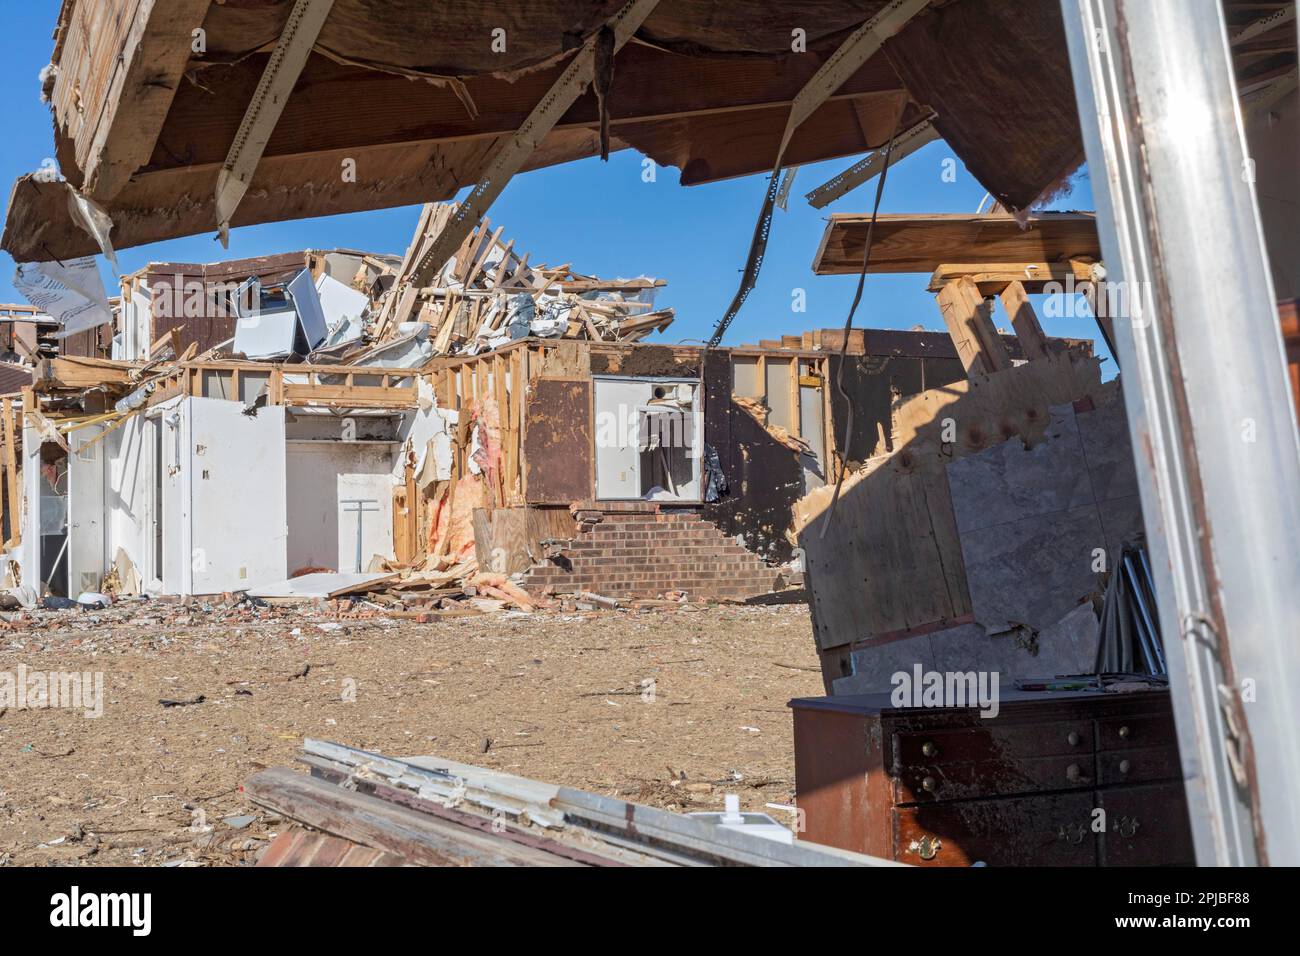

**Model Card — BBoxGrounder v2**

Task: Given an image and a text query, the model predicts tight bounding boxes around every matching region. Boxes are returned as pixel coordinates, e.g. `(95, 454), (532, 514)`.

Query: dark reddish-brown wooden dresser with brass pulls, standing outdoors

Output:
(790, 691), (1195, 866)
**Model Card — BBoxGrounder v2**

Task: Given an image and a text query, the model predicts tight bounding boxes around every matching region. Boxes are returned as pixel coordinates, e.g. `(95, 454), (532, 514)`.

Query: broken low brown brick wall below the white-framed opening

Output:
(524, 502), (779, 600)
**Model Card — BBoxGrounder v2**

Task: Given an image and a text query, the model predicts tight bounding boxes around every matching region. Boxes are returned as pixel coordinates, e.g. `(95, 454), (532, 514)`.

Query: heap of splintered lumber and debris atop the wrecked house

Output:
(92, 204), (673, 368)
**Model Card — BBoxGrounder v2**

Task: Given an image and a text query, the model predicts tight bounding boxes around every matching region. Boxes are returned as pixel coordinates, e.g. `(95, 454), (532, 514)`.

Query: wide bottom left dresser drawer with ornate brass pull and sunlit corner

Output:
(893, 791), (1097, 866)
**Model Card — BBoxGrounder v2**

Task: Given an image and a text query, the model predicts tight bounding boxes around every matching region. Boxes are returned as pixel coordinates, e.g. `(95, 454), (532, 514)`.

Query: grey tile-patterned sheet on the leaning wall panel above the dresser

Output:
(832, 397), (1143, 693)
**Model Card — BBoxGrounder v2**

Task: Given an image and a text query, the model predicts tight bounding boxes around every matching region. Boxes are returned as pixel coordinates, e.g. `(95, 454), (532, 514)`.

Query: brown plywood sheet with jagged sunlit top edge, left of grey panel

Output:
(794, 352), (1114, 658)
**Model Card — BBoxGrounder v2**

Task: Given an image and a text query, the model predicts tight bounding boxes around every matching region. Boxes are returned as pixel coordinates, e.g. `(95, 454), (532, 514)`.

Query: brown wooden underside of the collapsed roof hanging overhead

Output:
(4, 0), (1079, 261)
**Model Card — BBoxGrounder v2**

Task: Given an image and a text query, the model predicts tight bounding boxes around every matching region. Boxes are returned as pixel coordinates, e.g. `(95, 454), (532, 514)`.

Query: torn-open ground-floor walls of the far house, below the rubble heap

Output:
(5, 312), (1076, 598)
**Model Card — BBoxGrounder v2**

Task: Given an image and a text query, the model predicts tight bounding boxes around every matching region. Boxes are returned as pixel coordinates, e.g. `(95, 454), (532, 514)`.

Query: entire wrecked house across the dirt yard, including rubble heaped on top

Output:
(5, 206), (1087, 604)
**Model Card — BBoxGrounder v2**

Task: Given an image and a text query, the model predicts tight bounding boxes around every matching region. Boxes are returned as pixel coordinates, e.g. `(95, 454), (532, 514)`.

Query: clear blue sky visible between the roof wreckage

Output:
(0, 0), (1113, 372)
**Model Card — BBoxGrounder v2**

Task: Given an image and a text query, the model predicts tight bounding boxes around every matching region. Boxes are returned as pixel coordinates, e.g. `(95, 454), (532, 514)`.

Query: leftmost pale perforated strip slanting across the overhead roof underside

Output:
(216, 0), (334, 247)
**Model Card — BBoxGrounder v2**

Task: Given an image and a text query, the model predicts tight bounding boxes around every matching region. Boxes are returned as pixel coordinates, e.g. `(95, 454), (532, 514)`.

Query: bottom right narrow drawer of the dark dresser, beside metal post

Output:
(1097, 780), (1196, 866)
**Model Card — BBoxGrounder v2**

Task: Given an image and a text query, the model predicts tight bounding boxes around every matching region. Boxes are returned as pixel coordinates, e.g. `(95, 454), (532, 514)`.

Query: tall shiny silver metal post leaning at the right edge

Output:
(1062, 0), (1300, 865)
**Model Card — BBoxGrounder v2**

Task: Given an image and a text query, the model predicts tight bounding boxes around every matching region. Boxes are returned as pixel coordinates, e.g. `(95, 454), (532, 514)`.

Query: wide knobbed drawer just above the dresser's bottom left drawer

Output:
(893, 753), (1097, 804)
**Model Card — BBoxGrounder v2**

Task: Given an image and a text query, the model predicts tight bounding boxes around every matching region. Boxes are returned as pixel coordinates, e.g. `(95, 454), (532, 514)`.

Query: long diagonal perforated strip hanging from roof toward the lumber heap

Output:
(411, 0), (659, 286)
